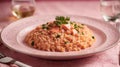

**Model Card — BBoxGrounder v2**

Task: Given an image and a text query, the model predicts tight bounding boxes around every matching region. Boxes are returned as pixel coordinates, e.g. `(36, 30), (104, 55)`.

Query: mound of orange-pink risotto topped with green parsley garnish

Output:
(25, 16), (95, 52)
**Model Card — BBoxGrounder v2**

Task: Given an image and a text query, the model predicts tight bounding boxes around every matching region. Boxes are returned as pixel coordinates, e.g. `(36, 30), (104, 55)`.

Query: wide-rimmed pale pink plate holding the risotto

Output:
(1, 15), (120, 60)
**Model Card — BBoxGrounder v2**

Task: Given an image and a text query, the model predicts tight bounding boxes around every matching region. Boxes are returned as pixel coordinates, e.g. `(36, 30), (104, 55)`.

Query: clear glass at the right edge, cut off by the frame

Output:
(100, 0), (120, 30)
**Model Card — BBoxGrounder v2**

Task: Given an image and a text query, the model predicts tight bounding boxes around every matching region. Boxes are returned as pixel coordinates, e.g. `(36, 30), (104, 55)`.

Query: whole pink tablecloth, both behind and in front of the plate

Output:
(0, 1), (119, 67)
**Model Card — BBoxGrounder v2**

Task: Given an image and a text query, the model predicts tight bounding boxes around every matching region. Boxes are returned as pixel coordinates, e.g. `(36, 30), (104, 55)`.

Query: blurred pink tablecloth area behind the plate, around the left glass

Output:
(0, 0), (101, 28)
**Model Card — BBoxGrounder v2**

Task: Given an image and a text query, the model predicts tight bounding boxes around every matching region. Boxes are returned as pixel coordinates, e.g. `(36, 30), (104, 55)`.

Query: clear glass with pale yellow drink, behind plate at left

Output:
(12, 0), (35, 18)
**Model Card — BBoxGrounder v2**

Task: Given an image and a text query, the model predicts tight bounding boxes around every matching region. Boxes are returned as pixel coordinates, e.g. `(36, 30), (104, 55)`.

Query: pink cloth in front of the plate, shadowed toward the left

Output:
(0, 44), (120, 67)
